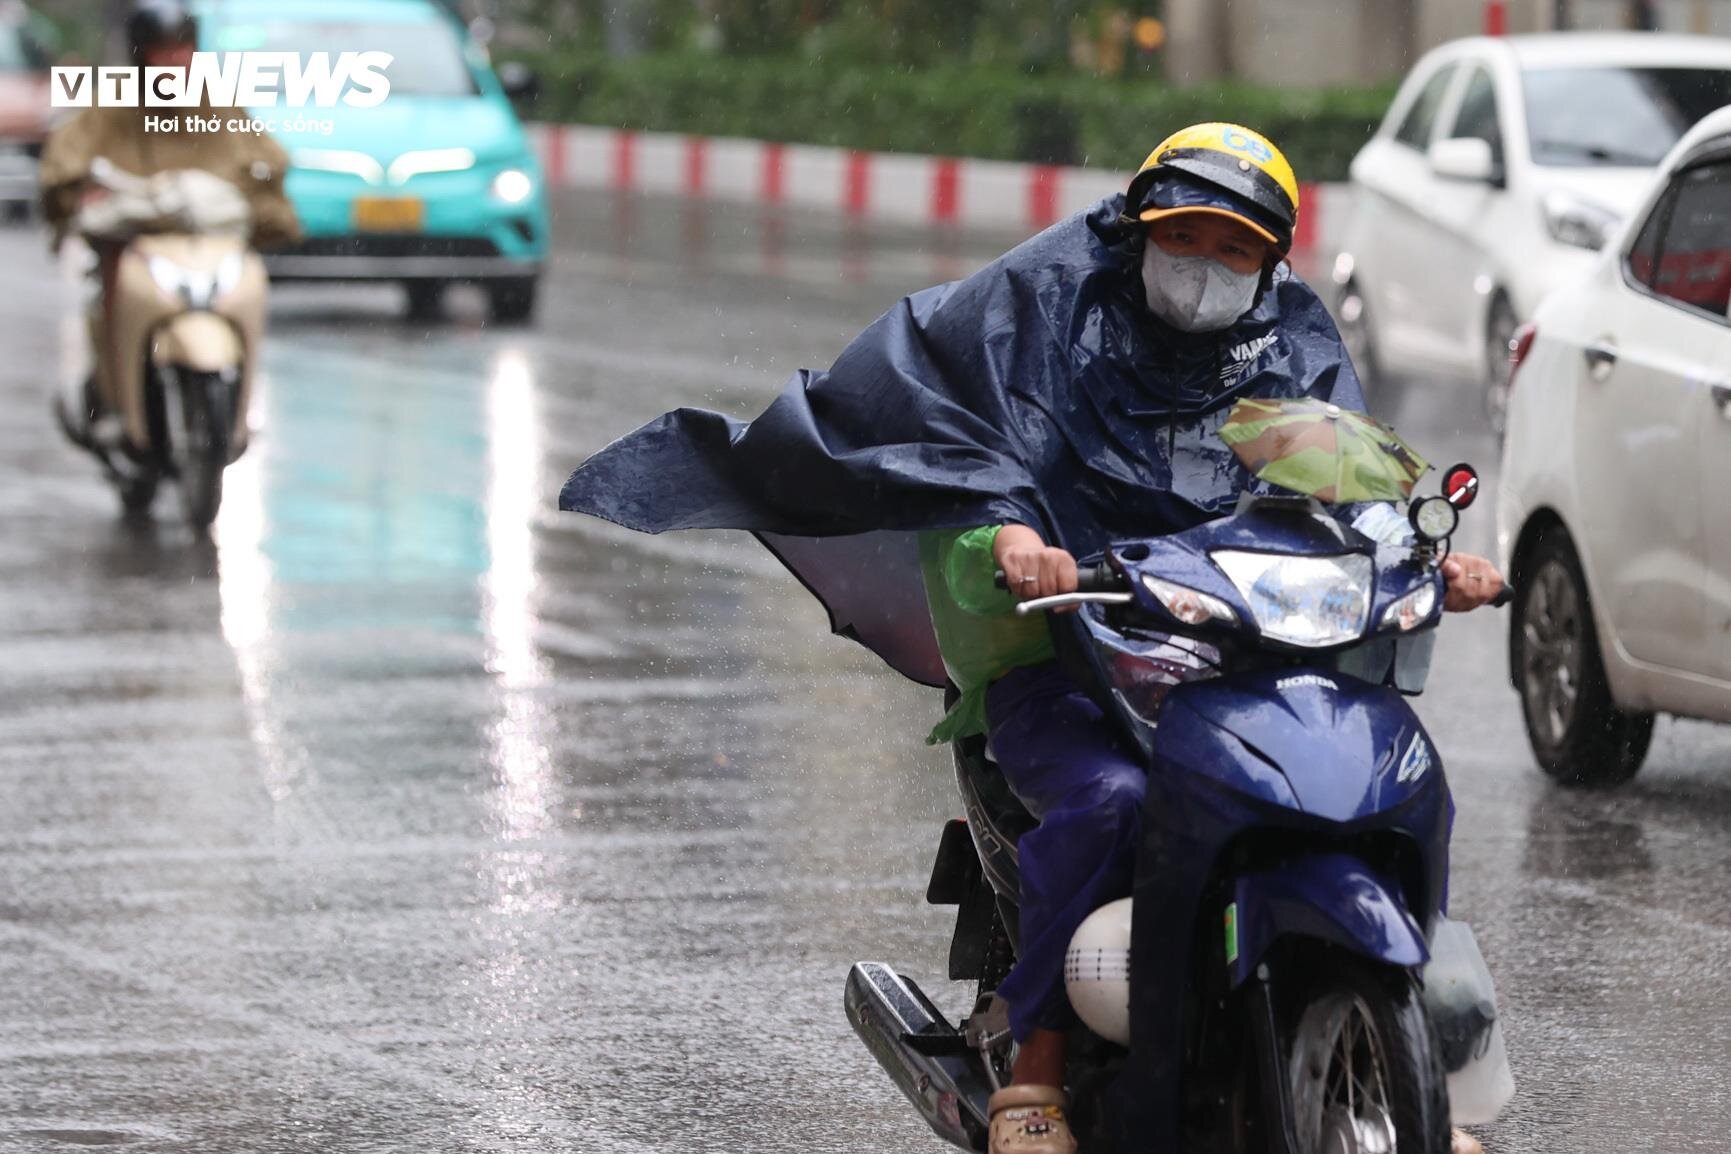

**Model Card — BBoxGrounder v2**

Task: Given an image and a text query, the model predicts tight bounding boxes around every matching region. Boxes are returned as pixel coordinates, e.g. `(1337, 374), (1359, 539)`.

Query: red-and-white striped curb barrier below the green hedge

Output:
(530, 125), (1350, 254)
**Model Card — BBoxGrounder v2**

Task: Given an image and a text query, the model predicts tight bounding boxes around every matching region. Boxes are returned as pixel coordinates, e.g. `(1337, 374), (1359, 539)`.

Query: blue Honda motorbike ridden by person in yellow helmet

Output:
(845, 465), (1477, 1154)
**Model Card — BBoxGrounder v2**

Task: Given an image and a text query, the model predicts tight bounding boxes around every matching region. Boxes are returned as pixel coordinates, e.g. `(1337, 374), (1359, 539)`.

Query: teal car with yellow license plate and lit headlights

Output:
(199, 0), (549, 322)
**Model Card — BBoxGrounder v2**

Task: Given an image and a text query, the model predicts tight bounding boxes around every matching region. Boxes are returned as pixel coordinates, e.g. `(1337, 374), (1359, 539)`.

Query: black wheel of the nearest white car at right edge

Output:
(1509, 528), (1653, 787)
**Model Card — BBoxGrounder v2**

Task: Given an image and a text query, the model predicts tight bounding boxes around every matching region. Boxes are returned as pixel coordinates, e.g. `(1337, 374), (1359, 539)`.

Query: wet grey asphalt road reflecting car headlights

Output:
(0, 197), (1731, 1154)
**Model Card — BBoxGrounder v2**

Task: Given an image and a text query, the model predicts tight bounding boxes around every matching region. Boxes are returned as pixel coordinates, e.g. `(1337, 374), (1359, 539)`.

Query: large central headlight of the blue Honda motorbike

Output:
(1213, 550), (1371, 649)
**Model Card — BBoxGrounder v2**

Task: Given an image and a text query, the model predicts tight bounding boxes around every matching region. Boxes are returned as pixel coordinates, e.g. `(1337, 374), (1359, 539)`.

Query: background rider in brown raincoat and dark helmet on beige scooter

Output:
(40, 0), (301, 442)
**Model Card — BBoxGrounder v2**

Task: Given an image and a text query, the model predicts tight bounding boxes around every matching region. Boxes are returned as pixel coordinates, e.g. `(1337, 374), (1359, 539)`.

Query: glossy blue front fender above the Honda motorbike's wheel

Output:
(1226, 853), (1430, 988)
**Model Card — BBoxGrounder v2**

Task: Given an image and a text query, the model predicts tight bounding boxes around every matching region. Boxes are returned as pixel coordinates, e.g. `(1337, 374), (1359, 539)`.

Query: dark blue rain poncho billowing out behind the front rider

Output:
(559, 196), (1364, 685)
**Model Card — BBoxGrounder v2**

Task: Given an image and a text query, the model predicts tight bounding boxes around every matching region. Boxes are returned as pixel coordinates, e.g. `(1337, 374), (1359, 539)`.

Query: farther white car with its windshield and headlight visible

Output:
(1333, 33), (1731, 429)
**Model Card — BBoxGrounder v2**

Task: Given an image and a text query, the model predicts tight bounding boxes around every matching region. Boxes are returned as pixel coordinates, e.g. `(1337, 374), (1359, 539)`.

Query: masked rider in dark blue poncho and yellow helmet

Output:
(561, 123), (1503, 1154)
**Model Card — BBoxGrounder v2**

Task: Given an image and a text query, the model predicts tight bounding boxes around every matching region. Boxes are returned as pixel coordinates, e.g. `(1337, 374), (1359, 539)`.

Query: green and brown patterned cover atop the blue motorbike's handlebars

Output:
(1220, 398), (1430, 503)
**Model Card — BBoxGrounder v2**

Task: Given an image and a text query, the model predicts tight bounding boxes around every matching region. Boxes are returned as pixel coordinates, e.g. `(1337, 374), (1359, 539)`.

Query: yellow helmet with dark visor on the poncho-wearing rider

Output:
(1125, 121), (1298, 256)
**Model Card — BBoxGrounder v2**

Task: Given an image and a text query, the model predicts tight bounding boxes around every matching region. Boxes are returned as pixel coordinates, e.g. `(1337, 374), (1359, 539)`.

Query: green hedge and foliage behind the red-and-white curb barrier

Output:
(492, 0), (1390, 180)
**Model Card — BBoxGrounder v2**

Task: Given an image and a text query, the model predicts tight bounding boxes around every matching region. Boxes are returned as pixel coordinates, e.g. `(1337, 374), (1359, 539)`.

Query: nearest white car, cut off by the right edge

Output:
(1497, 101), (1731, 784)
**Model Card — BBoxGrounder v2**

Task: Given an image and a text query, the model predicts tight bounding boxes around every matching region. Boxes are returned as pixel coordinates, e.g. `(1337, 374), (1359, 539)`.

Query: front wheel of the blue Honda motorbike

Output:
(1286, 962), (1451, 1154)
